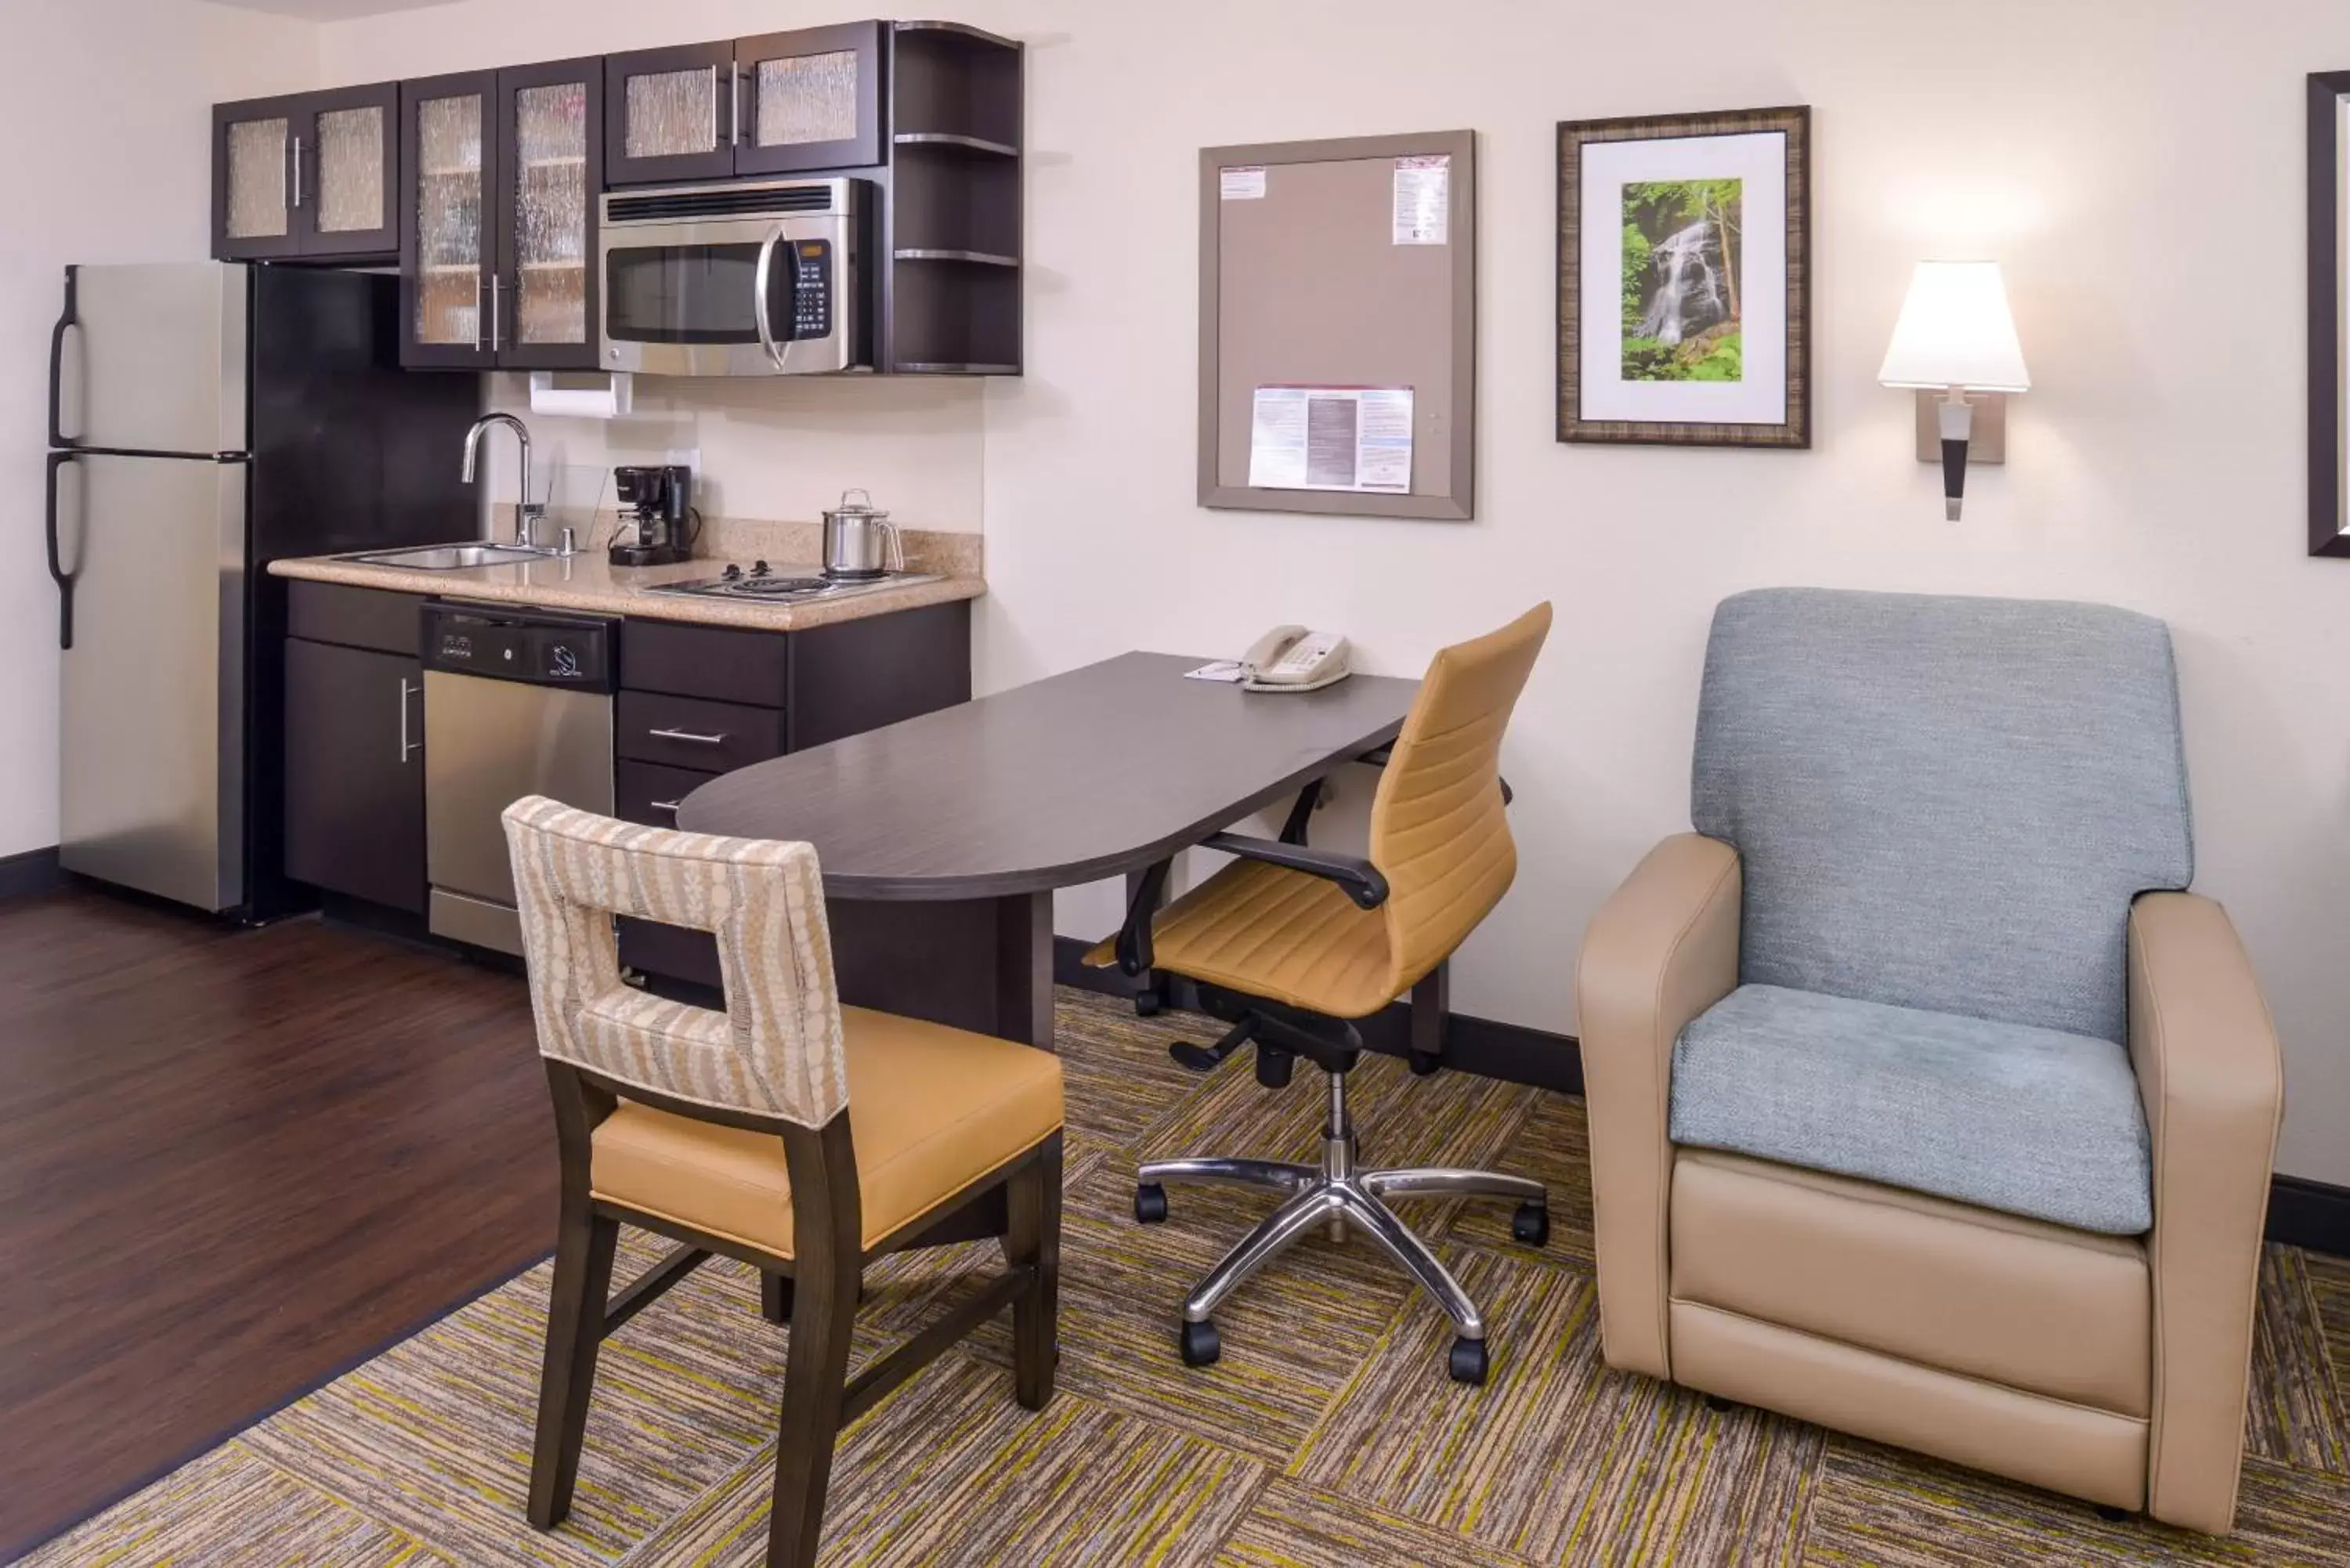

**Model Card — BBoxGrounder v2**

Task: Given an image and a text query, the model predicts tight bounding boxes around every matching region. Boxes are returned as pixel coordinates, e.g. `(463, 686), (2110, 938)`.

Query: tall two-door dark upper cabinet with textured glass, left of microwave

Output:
(400, 59), (604, 369)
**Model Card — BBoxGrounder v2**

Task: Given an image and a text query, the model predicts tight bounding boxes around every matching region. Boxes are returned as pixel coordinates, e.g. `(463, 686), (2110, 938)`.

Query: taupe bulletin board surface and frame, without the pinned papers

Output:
(1198, 129), (1476, 522)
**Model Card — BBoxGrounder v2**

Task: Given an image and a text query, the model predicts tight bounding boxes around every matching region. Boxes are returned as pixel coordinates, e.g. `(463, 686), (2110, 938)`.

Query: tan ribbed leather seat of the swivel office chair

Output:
(1086, 861), (1394, 1018)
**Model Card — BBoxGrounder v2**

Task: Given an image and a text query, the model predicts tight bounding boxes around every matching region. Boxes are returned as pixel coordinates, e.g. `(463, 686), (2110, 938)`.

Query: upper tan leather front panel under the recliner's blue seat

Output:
(1673, 1150), (2153, 1418)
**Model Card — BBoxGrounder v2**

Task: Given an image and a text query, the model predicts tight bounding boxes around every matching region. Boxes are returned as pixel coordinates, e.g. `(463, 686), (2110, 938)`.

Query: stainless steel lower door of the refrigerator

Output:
(59, 453), (247, 910)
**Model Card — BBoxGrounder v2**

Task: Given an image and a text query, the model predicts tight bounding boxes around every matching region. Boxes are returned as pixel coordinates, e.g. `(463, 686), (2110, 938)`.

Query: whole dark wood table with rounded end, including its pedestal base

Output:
(677, 653), (1419, 1049)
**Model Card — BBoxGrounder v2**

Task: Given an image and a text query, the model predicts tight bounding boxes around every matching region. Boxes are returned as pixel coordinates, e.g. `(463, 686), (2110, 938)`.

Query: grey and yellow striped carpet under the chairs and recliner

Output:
(28, 992), (2350, 1568)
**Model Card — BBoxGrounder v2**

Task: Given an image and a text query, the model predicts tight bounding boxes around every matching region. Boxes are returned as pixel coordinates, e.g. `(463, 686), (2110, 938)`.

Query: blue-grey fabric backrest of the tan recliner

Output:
(1690, 587), (2195, 1042)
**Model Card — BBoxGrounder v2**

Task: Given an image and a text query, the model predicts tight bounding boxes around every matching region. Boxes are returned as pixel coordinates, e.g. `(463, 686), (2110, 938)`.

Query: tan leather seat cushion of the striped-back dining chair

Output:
(590, 1006), (1062, 1258)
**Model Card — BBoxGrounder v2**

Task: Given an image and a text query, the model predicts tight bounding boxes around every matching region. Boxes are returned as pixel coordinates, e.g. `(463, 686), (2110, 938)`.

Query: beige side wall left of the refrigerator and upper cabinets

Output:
(0, 0), (317, 856)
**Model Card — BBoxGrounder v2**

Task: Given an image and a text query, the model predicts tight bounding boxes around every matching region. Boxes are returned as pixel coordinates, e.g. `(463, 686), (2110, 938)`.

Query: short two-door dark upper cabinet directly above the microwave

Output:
(604, 21), (888, 186)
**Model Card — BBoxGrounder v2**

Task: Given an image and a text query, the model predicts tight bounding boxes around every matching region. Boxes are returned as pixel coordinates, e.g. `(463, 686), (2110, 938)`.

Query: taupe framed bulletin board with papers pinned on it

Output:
(1198, 132), (1476, 519)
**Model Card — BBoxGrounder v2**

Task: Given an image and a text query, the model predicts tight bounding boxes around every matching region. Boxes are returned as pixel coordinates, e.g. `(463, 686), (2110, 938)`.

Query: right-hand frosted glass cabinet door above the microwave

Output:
(736, 21), (886, 174)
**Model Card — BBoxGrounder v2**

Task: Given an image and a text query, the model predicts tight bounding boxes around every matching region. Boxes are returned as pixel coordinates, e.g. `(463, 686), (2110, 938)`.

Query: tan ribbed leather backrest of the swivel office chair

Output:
(1370, 602), (1551, 995)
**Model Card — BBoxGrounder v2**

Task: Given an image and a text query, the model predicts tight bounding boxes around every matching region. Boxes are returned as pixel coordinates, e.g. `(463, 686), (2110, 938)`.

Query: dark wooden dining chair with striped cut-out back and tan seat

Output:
(505, 795), (1062, 1568)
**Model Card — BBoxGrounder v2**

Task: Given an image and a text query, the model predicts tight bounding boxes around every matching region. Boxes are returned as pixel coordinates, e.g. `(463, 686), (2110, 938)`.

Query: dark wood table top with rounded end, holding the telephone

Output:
(677, 653), (1419, 901)
